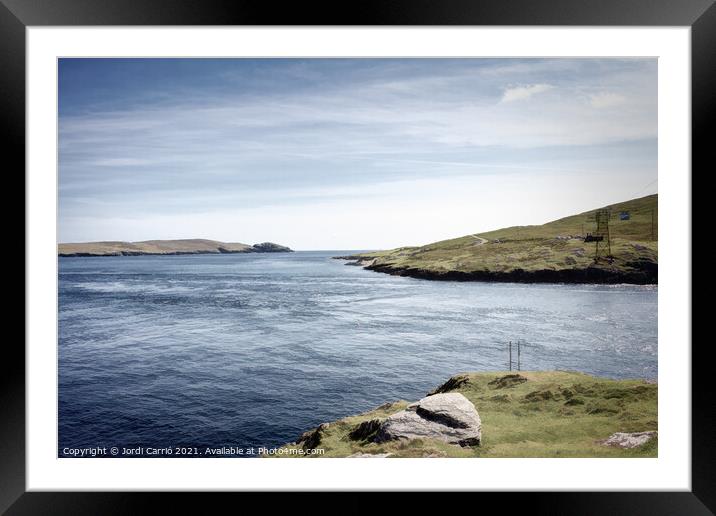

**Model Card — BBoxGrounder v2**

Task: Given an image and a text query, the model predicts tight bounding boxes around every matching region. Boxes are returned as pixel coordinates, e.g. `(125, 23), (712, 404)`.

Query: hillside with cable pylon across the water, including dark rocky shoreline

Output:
(354, 195), (658, 283)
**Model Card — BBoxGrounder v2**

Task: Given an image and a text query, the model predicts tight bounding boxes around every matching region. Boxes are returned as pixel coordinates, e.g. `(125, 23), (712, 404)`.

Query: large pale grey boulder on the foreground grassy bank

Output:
(374, 392), (482, 446)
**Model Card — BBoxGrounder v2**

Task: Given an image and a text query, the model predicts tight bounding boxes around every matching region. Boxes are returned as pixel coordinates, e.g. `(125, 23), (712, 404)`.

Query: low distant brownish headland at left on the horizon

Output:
(57, 239), (292, 256)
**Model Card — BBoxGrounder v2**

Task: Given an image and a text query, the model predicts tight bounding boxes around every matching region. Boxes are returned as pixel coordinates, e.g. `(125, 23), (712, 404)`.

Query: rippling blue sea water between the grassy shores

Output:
(59, 251), (657, 455)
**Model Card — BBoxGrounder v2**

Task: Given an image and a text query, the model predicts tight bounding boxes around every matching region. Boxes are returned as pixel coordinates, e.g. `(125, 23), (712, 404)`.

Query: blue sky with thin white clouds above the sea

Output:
(58, 58), (658, 250)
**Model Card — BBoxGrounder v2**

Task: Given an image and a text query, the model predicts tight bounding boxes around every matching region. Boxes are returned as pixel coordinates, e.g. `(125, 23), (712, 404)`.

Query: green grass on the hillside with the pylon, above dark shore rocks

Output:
(360, 195), (658, 273)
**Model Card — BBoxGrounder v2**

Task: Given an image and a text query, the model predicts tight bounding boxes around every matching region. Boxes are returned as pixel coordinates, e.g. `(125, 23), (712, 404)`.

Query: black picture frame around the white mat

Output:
(0, 0), (716, 515)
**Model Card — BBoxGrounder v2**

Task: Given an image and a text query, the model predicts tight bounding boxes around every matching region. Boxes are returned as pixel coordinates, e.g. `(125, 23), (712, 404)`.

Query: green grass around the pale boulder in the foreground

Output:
(270, 371), (658, 458)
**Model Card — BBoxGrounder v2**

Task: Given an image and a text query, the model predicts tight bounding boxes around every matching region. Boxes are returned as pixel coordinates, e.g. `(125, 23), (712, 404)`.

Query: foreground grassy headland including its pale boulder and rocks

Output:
(265, 371), (658, 458)
